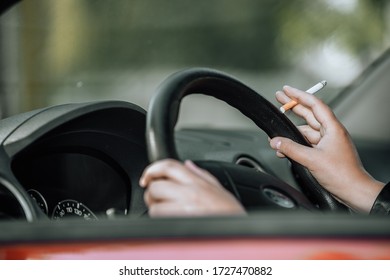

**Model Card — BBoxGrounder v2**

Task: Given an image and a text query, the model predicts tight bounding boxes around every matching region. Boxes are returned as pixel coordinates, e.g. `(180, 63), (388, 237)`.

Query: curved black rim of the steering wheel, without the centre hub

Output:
(146, 68), (345, 211)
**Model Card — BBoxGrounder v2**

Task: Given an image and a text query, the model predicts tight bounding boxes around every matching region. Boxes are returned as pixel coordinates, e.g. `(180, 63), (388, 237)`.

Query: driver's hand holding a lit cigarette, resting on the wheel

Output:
(270, 86), (384, 212)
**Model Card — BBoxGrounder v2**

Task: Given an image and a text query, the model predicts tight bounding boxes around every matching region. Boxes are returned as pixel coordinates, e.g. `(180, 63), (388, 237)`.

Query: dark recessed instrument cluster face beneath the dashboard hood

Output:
(13, 131), (139, 219)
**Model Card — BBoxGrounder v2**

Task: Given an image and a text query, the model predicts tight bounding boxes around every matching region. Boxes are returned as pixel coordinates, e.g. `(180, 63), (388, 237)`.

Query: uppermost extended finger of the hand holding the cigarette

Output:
(283, 86), (337, 127)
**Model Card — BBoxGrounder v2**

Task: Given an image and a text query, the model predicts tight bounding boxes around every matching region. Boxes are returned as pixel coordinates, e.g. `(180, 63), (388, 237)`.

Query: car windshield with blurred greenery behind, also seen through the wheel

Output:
(0, 0), (390, 127)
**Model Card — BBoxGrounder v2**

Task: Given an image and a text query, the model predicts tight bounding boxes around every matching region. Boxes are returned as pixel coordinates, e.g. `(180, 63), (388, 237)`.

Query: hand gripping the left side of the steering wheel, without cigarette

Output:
(140, 159), (245, 216)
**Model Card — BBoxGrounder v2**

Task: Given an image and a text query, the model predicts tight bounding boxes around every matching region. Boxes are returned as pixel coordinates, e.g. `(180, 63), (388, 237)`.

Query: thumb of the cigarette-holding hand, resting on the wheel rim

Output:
(270, 137), (314, 167)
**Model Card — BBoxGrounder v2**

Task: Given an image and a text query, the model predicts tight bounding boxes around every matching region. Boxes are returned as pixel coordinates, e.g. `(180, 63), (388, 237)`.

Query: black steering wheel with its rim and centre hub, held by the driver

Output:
(146, 68), (346, 211)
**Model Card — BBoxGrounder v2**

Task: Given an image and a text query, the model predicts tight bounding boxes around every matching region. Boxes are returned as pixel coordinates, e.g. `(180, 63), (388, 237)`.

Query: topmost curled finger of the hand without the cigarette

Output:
(139, 159), (193, 187)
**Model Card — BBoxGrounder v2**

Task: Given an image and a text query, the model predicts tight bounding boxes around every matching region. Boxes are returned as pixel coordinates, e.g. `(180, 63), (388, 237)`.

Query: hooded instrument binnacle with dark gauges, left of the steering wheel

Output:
(1, 102), (148, 220)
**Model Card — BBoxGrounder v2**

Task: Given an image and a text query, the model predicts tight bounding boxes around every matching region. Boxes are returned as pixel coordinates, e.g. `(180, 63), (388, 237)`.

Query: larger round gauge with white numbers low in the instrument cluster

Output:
(52, 199), (97, 220)
